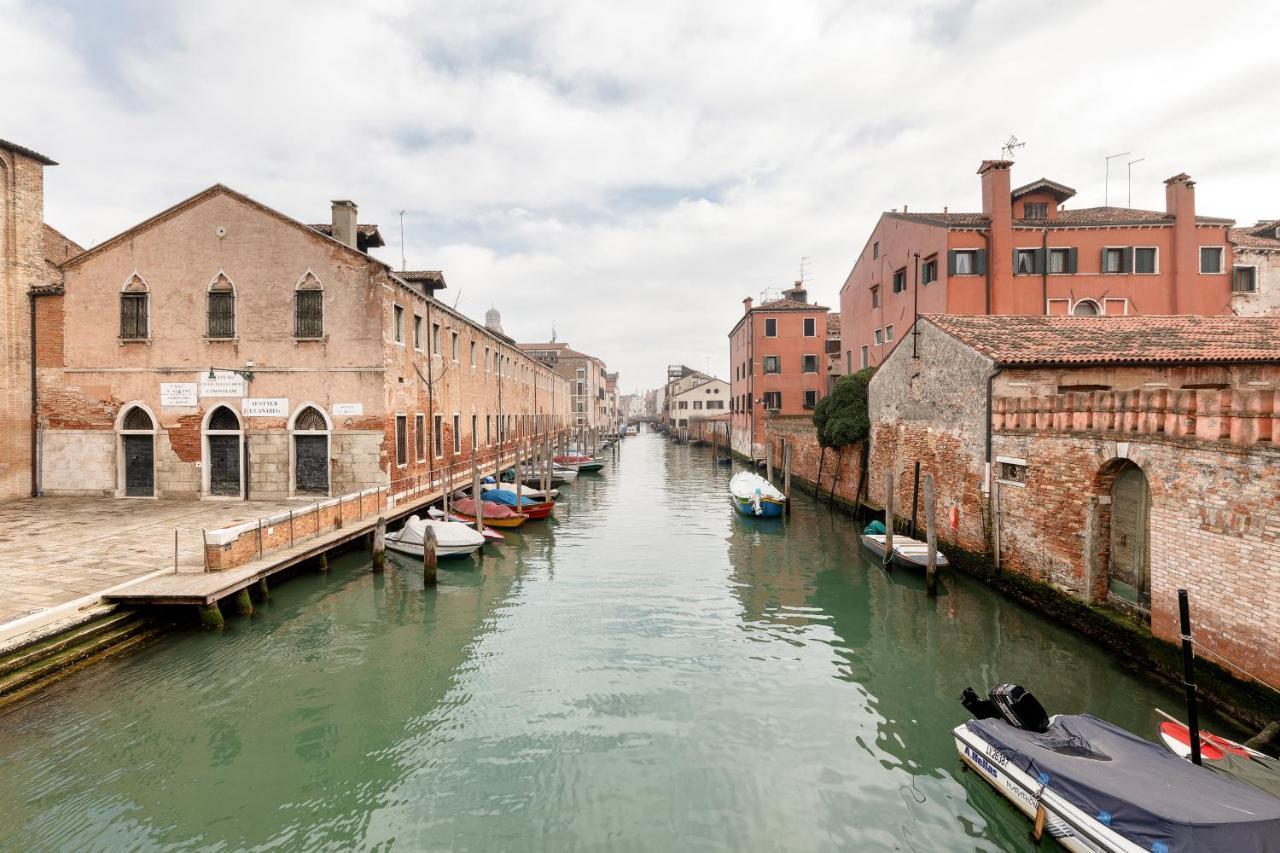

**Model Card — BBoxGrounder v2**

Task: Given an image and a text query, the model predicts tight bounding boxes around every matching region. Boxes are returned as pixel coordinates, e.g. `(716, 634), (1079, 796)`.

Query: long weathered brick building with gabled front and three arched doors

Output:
(36, 186), (568, 500)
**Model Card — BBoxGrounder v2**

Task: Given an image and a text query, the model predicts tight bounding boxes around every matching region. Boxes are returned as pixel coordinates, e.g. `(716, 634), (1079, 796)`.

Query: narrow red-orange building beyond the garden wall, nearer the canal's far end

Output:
(728, 282), (828, 459)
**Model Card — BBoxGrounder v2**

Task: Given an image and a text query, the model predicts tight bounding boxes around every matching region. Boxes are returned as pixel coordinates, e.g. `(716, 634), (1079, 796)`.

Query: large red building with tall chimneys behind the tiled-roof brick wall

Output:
(840, 160), (1260, 373)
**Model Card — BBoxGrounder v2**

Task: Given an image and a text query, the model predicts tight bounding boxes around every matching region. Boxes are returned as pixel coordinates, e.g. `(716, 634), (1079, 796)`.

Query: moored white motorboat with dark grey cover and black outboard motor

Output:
(952, 684), (1280, 853)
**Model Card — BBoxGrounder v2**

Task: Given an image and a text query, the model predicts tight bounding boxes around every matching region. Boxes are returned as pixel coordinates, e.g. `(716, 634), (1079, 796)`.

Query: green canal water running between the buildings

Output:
(0, 434), (1239, 852)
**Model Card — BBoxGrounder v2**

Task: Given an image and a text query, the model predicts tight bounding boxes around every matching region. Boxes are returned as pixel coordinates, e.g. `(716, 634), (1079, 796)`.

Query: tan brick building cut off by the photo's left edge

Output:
(0, 140), (81, 500)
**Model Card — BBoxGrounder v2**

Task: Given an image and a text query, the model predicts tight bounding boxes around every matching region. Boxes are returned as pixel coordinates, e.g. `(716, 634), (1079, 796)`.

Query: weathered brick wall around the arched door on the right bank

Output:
(995, 430), (1280, 685)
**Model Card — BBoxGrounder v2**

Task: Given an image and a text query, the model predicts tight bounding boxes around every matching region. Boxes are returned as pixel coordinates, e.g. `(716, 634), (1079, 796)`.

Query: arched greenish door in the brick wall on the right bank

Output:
(1107, 461), (1151, 611)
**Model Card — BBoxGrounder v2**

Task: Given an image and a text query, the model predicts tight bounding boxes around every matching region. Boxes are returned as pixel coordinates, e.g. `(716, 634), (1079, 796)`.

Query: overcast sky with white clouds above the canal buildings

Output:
(0, 0), (1280, 392)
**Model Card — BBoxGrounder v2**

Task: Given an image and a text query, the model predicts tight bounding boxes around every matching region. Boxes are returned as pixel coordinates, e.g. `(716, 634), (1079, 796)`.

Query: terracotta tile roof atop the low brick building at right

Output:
(922, 314), (1280, 365)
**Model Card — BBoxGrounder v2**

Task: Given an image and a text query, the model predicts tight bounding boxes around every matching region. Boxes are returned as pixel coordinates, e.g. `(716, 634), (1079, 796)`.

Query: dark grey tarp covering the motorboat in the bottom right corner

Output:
(965, 715), (1280, 853)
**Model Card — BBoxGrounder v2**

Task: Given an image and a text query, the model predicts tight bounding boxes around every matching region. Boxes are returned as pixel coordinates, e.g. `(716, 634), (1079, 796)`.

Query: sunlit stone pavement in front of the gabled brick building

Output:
(0, 497), (307, 626)
